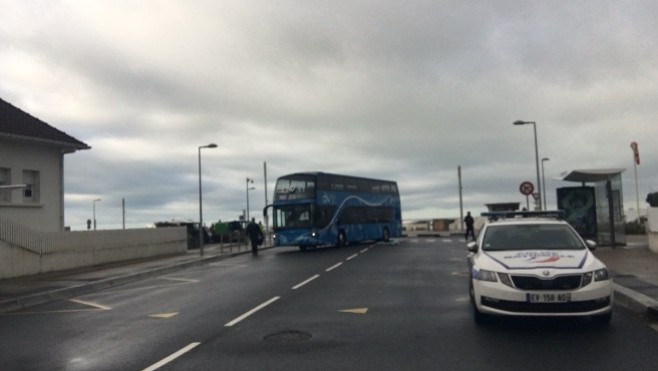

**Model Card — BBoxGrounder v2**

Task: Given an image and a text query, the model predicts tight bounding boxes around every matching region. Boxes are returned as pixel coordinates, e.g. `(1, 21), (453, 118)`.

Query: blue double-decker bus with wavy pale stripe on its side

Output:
(263, 172), (402, 250)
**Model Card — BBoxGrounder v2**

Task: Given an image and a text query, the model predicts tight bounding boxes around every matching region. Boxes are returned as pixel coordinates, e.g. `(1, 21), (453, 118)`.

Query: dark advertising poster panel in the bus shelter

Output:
(557, 187), (597, 240)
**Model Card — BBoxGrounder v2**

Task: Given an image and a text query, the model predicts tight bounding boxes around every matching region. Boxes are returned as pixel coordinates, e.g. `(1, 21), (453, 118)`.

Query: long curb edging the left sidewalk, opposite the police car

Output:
(0, 247), (256, 313)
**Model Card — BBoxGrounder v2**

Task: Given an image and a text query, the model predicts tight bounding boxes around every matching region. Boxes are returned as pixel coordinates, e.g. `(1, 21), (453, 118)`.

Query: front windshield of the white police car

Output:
(482, 224), (586, 251)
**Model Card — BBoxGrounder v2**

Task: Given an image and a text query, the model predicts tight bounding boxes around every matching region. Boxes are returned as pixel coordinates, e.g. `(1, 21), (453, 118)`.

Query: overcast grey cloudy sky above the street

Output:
(0, 0), (658, 229)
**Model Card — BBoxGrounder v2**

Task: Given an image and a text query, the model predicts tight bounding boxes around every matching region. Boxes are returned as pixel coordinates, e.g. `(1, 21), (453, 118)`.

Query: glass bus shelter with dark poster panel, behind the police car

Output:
(557, 169), (626, 247)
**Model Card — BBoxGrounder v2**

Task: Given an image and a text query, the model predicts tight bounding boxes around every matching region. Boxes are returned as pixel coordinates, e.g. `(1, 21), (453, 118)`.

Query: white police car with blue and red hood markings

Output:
(468, 212), (613, 323)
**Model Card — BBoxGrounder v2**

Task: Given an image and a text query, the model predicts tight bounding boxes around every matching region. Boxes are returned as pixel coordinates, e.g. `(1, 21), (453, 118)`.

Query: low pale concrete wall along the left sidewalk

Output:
(0, 228), (187, 279)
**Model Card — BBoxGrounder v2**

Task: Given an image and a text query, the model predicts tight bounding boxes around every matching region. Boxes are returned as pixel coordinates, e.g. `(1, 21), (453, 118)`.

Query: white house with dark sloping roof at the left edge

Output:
(0, 99), (91, 231)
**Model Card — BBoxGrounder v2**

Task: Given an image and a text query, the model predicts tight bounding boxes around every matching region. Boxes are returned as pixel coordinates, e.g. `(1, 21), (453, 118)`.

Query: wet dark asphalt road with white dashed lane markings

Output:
(0, 238), (658, 371)
